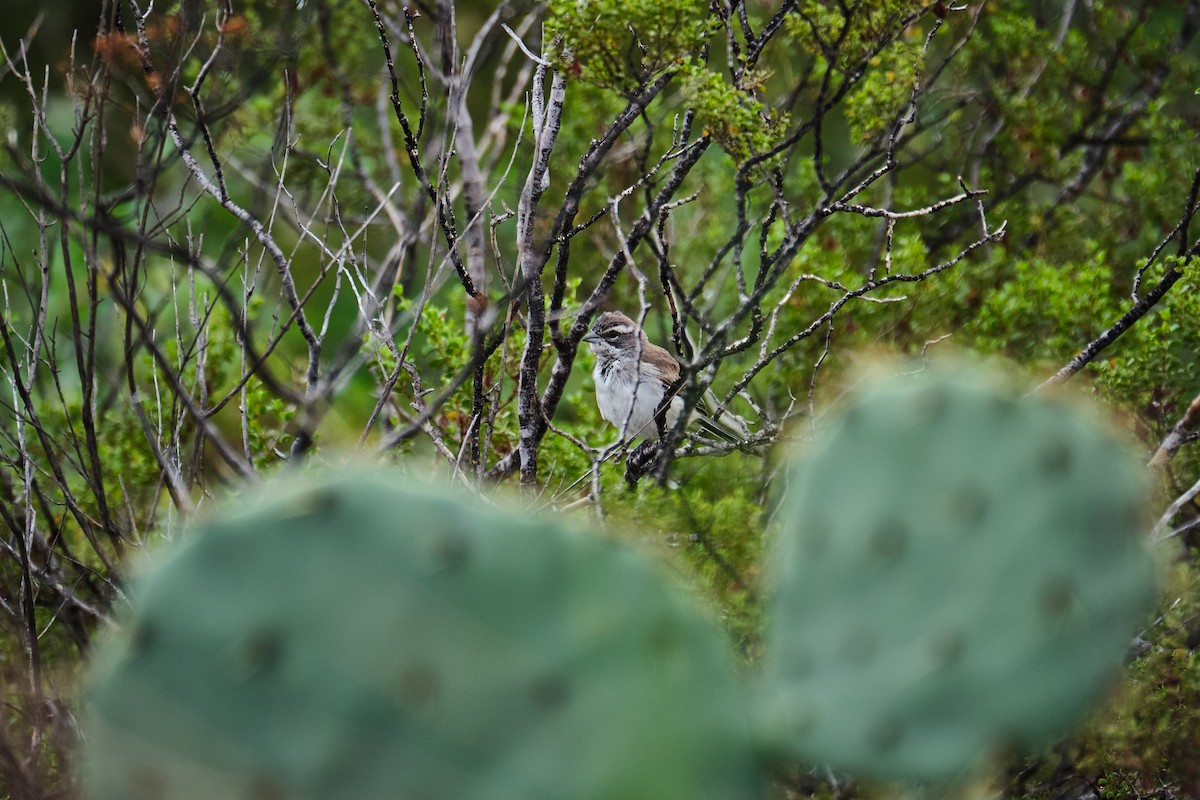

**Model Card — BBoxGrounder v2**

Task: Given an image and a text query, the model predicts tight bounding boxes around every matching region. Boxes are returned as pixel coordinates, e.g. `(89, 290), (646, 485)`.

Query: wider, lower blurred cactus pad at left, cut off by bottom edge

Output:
(84, 475), (760, 800)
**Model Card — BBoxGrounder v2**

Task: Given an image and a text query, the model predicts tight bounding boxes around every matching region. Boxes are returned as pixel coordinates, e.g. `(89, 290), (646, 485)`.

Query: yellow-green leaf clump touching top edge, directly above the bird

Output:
(546, 0), (713, 92)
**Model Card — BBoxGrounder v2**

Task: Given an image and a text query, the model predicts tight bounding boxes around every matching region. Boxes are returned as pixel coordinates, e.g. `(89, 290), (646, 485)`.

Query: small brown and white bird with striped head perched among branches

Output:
(583, 311), (749, 441)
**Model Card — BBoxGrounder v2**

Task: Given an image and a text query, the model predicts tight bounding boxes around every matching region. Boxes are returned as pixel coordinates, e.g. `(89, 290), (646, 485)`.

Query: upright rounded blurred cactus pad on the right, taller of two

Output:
(763, 365), (1154, 781)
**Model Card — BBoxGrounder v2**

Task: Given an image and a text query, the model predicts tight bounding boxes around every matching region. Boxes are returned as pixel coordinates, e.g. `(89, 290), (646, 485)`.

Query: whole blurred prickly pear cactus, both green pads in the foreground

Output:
(85, 369), (1154, 800)
